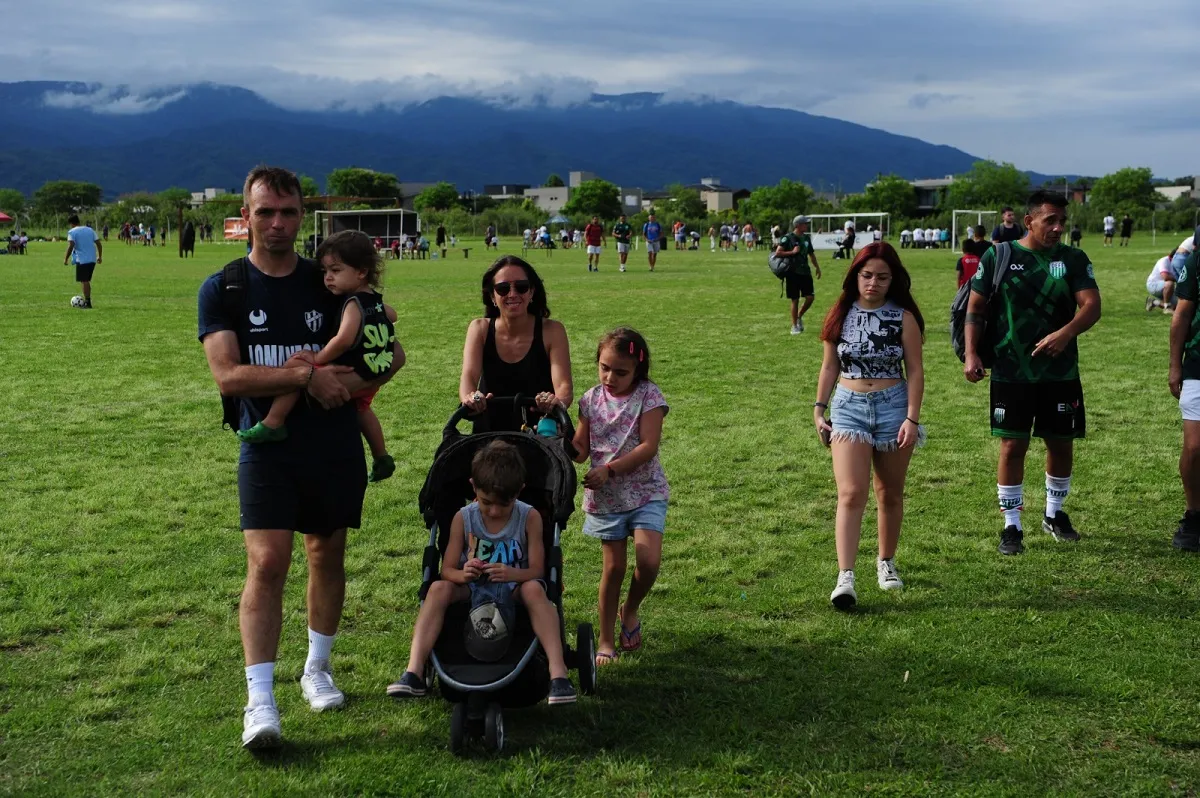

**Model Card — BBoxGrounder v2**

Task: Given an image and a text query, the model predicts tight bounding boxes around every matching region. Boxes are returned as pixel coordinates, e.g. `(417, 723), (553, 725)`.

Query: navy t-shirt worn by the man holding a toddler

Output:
(198, 258), (362, 462)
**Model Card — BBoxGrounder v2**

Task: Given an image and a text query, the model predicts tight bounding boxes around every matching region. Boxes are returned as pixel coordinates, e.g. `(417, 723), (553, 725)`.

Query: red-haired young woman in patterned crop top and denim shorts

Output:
(812, 242), (925, 610)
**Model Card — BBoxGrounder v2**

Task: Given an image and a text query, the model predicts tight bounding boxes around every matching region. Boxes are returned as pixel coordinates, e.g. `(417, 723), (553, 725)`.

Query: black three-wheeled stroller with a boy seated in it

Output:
(419, 396), (596, 754)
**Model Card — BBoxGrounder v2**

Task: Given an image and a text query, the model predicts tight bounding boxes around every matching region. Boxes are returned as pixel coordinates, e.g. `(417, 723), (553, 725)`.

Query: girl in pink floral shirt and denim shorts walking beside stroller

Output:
(575, 328), (671, 665)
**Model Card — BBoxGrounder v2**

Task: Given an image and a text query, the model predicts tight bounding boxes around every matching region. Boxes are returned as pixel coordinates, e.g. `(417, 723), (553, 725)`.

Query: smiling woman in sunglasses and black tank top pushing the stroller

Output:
(458, 256), (574, 432)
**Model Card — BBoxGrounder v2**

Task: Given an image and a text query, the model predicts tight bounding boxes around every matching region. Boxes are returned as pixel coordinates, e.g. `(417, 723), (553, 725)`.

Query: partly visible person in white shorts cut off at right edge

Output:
(1168, 242), (1200, 551)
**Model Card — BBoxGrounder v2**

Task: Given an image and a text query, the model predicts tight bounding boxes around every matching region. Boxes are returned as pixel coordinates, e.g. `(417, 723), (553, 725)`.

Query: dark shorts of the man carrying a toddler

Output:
(238, 453), (367, 535)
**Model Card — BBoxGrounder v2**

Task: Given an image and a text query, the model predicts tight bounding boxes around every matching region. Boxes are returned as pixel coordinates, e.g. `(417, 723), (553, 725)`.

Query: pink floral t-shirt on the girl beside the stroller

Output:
(580, 379), (671, 515)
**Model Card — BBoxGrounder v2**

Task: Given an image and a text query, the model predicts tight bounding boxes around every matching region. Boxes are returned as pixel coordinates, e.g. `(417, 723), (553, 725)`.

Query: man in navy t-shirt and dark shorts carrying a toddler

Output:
(199, 167), (403, 748)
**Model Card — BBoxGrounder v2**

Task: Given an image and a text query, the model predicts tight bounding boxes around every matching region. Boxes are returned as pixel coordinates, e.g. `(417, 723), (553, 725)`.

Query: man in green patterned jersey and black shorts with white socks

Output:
(964, 191), (1100, 554)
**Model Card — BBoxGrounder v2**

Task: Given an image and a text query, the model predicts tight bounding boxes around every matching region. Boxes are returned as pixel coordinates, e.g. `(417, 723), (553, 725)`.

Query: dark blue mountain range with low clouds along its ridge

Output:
(0, 82), (1044, 198)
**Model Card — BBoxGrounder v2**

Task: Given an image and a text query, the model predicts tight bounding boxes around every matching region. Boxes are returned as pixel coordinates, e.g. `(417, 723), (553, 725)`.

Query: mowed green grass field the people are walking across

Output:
(0, 234), (1200, 796)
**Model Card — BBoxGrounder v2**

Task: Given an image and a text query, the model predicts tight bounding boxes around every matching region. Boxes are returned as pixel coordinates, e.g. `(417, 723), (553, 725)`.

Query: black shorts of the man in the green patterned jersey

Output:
(991, 379), (1087, 439)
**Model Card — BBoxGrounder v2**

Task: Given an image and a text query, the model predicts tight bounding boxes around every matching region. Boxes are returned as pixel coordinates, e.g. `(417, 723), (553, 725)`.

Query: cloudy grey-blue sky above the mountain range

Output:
(0, 0), (1200, 178)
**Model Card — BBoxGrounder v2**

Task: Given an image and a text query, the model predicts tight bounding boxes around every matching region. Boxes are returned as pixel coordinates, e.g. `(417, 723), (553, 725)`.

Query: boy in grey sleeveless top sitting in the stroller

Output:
(388, 440), (575, 704)
